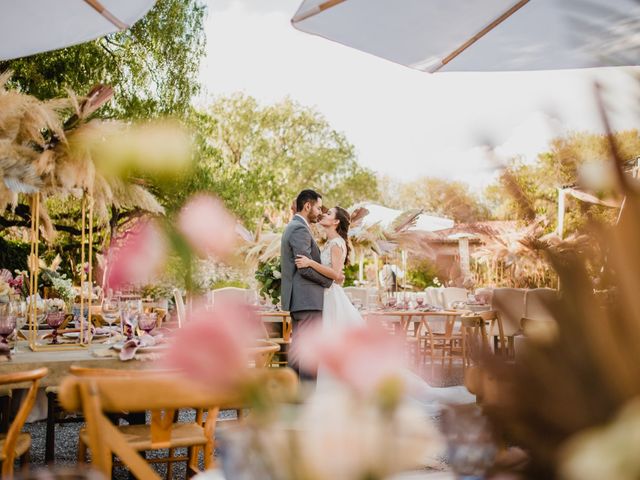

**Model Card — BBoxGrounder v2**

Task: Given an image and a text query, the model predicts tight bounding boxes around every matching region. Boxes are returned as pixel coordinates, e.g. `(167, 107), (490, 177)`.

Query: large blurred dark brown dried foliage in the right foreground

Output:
(484, 87), (640, 479)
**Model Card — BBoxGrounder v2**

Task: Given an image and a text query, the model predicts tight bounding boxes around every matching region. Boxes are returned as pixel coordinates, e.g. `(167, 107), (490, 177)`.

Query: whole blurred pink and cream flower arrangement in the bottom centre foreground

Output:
(166, 304), (442, 480)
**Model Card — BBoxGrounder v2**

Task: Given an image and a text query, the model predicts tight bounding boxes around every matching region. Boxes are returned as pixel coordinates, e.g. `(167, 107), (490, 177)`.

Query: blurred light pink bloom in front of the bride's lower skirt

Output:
(291, 325), (407, 394)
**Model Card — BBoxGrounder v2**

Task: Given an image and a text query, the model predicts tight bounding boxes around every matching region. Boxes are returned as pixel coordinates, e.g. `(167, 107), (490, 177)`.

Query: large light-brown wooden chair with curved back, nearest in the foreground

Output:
(60, 368), (297, 479)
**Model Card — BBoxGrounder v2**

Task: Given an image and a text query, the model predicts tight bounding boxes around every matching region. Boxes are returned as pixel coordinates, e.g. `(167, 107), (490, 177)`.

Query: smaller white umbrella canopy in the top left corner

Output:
(0, 0), (155, 60)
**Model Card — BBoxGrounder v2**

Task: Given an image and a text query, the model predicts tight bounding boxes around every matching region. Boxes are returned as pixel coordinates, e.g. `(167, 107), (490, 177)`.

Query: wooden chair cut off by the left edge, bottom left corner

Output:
(0, 368), (49, 479)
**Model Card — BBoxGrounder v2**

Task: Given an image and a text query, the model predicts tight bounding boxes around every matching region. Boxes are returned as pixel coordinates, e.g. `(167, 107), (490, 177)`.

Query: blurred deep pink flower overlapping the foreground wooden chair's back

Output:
(165, 302), (262, 389)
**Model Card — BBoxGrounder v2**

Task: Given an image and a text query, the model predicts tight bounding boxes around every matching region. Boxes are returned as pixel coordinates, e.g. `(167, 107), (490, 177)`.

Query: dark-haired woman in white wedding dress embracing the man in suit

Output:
(296, 206), (475, 406)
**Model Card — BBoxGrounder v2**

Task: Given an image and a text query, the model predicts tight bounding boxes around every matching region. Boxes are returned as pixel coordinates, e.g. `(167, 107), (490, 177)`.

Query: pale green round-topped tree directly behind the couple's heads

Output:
(171, 94), (378, 226)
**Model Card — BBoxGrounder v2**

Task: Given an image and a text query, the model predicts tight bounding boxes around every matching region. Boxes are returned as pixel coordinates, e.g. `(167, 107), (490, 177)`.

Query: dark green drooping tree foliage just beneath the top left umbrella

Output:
(0, 0), (206, 119)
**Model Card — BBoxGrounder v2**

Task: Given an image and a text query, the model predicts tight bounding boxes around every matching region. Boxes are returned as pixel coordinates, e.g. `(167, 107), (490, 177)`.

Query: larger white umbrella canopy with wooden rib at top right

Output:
(292, 0), (640, 72)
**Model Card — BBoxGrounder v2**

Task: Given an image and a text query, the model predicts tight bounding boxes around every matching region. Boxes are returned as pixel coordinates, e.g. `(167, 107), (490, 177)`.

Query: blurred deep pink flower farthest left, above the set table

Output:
(107, 220), (167, 290)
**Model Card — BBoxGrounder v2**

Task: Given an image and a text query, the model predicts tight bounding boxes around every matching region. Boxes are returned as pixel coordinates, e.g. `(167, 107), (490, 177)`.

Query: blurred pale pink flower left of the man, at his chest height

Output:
(178, 193), (237, 259)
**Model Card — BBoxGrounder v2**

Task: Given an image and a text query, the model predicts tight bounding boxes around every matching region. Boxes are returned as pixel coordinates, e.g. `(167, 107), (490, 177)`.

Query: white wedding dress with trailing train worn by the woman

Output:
(316, 237), (476, 415)
